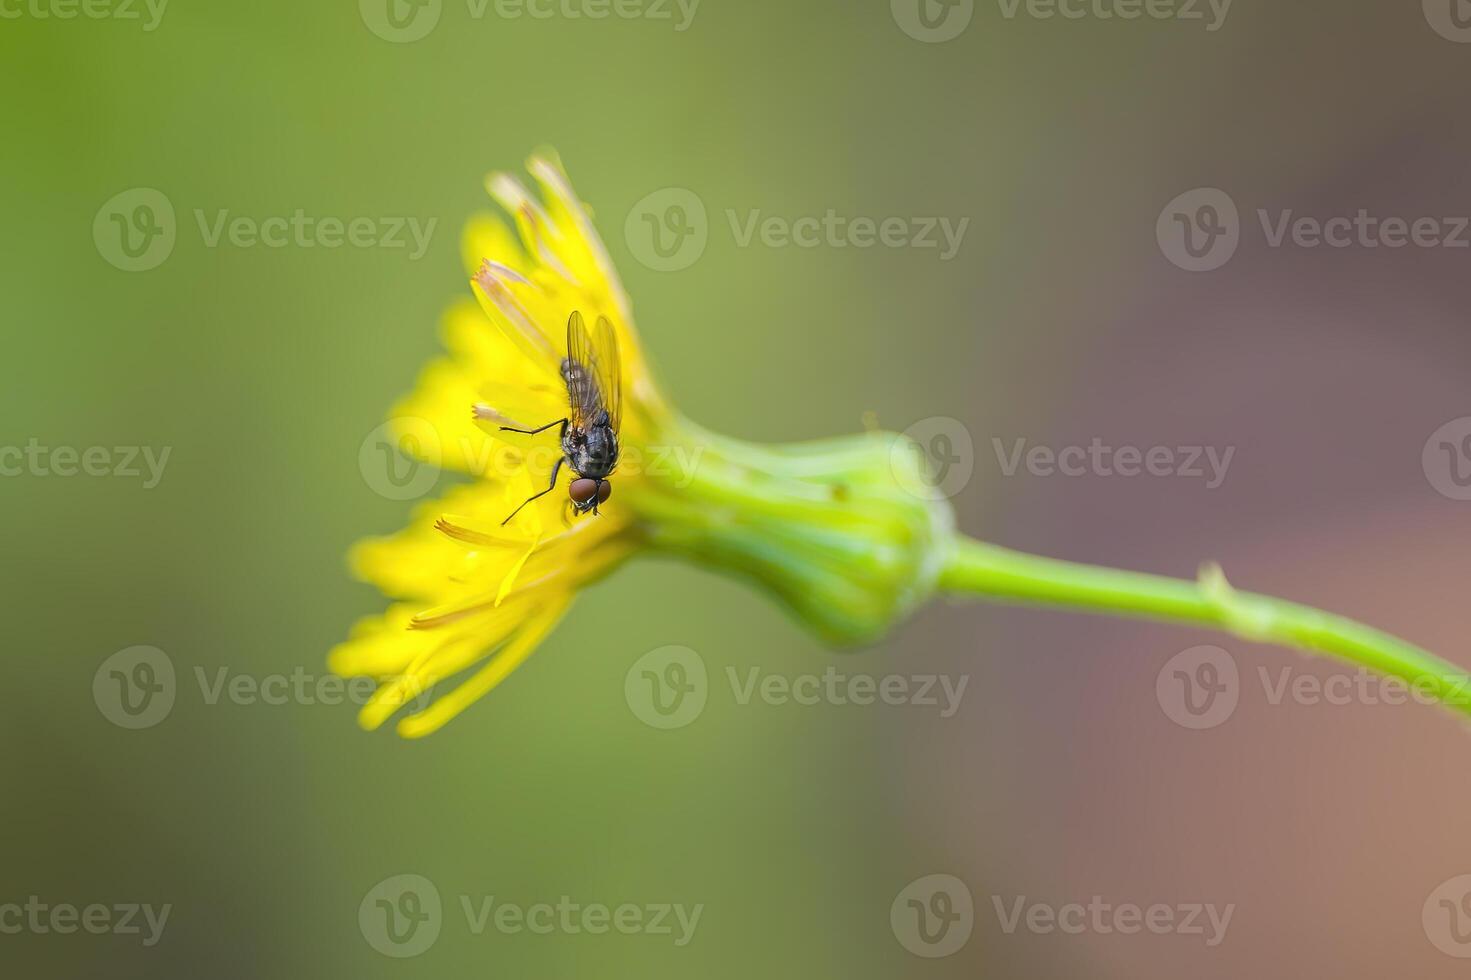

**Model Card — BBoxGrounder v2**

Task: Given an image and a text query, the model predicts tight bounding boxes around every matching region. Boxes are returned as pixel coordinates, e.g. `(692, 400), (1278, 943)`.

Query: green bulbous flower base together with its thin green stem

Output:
(630, 416), (1471, 715)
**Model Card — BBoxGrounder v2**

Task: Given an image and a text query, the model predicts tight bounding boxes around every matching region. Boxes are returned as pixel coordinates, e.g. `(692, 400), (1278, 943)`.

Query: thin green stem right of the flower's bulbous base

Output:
(938, 536), (1471, 714)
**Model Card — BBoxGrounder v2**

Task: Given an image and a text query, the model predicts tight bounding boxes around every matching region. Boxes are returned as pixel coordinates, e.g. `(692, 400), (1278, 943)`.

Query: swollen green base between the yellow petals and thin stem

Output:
(628, 419), (955, 645)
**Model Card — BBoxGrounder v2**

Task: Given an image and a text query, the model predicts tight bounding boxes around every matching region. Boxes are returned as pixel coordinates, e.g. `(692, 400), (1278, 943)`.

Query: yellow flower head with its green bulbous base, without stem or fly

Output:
(330, 157), (950, 737)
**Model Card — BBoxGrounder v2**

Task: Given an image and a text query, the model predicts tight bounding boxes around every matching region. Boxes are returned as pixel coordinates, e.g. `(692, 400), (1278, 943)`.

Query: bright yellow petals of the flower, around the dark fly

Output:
(330, 159), (665, 737)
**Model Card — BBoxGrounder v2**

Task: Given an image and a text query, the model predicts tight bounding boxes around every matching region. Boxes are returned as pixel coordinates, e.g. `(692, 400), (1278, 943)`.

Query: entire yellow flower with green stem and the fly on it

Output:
(330, 156), (1471, 739)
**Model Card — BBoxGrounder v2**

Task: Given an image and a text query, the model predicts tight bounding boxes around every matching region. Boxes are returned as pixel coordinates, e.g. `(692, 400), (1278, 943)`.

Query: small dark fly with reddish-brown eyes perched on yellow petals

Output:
(500, 310), (622, 527)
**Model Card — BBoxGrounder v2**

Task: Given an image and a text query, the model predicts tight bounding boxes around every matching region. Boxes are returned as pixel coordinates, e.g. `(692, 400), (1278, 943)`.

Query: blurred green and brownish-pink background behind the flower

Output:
(0, 0), (1471, 980)
